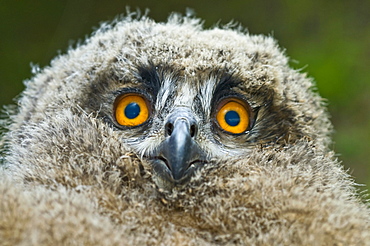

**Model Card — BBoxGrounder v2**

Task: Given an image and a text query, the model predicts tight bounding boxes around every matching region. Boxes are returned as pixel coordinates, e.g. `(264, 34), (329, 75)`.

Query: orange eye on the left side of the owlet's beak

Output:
(115, 94), (149, 126)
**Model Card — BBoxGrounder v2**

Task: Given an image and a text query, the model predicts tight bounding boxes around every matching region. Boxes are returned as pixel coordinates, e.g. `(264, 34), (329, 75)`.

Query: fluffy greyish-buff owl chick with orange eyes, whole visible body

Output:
(0, 14), (370, 245)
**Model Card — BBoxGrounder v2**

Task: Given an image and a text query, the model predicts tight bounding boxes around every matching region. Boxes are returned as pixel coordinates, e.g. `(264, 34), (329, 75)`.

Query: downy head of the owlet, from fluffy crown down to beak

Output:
(4, 14), (331, 189)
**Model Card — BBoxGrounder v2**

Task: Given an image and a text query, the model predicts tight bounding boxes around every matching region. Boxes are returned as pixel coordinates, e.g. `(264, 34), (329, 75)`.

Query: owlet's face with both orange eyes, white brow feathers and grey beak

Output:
(97, 65), (259, 187)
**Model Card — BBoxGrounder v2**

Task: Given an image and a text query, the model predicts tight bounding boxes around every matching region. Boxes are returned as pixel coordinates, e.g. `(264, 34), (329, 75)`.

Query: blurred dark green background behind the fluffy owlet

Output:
(0, 0), (370, 194)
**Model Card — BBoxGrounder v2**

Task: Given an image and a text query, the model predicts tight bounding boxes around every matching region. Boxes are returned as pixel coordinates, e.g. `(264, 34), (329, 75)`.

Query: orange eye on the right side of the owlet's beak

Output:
(216, 98), (249, 134)
